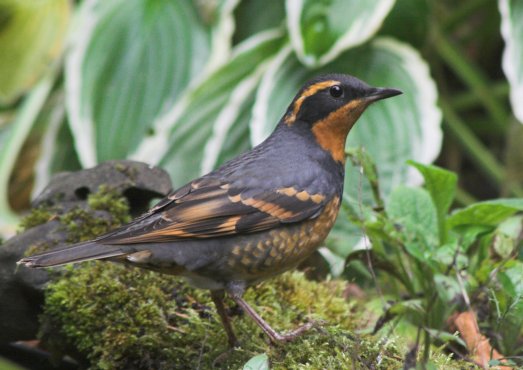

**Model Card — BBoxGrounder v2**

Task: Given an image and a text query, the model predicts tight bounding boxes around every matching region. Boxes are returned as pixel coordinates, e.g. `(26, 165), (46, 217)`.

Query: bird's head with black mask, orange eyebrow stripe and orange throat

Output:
(282, 74), (402, 163)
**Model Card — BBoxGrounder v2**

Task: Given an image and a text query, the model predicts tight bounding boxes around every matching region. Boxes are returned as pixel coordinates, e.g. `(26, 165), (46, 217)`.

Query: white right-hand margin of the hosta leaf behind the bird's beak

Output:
(372, 37), (443, 185)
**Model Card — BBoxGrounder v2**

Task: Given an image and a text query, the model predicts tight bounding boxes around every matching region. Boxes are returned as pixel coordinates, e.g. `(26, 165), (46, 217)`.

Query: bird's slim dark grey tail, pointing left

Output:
(18, 241), (128, 268)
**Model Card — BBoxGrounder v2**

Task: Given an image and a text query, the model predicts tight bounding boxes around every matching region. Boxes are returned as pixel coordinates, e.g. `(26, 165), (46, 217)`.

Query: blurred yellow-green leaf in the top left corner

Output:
(0, 0), (71, 104)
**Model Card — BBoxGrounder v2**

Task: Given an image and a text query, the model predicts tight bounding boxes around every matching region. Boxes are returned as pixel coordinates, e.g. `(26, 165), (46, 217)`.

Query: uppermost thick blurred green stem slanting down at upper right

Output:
(432, 26), (509, 132)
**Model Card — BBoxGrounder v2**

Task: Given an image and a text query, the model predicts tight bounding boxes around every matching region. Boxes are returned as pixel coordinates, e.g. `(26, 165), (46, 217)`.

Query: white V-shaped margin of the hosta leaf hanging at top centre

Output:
(285, 0), (396, 67)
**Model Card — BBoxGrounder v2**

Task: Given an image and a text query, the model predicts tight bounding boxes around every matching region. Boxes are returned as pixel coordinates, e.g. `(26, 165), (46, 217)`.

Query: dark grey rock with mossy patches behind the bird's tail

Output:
(0, 160), (172, 344)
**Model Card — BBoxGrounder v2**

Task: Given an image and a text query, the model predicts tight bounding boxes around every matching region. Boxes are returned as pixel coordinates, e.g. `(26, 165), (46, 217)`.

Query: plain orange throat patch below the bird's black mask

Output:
(312, 100), (365, 164)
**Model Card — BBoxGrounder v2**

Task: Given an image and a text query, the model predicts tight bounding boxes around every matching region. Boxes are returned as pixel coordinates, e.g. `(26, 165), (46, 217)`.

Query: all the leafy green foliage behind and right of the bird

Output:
(0, 0), (523, 368)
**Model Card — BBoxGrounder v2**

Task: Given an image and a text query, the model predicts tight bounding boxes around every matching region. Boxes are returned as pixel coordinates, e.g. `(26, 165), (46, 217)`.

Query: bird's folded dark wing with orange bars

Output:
(97, 177), (325, 244)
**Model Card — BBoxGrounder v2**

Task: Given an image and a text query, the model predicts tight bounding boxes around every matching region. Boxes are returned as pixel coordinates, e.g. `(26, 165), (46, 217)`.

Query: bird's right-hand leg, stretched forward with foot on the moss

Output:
(227, 284), (315, 343)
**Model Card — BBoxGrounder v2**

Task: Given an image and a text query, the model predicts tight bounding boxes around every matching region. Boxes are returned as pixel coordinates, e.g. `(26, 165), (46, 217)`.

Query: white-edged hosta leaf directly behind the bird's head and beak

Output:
(251, 38), (442, 256)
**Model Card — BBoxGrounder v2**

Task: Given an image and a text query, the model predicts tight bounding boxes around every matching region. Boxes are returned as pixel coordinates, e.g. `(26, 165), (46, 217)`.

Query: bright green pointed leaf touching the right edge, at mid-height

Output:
(447, 198), (523, 228)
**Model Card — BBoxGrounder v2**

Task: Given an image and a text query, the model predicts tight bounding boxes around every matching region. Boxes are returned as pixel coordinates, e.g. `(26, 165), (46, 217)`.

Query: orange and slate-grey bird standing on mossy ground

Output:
(18, 74), (402, 347)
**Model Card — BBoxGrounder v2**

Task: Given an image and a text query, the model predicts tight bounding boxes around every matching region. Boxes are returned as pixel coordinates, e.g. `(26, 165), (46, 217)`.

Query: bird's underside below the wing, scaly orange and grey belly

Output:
(127, 198), (340, 290)
